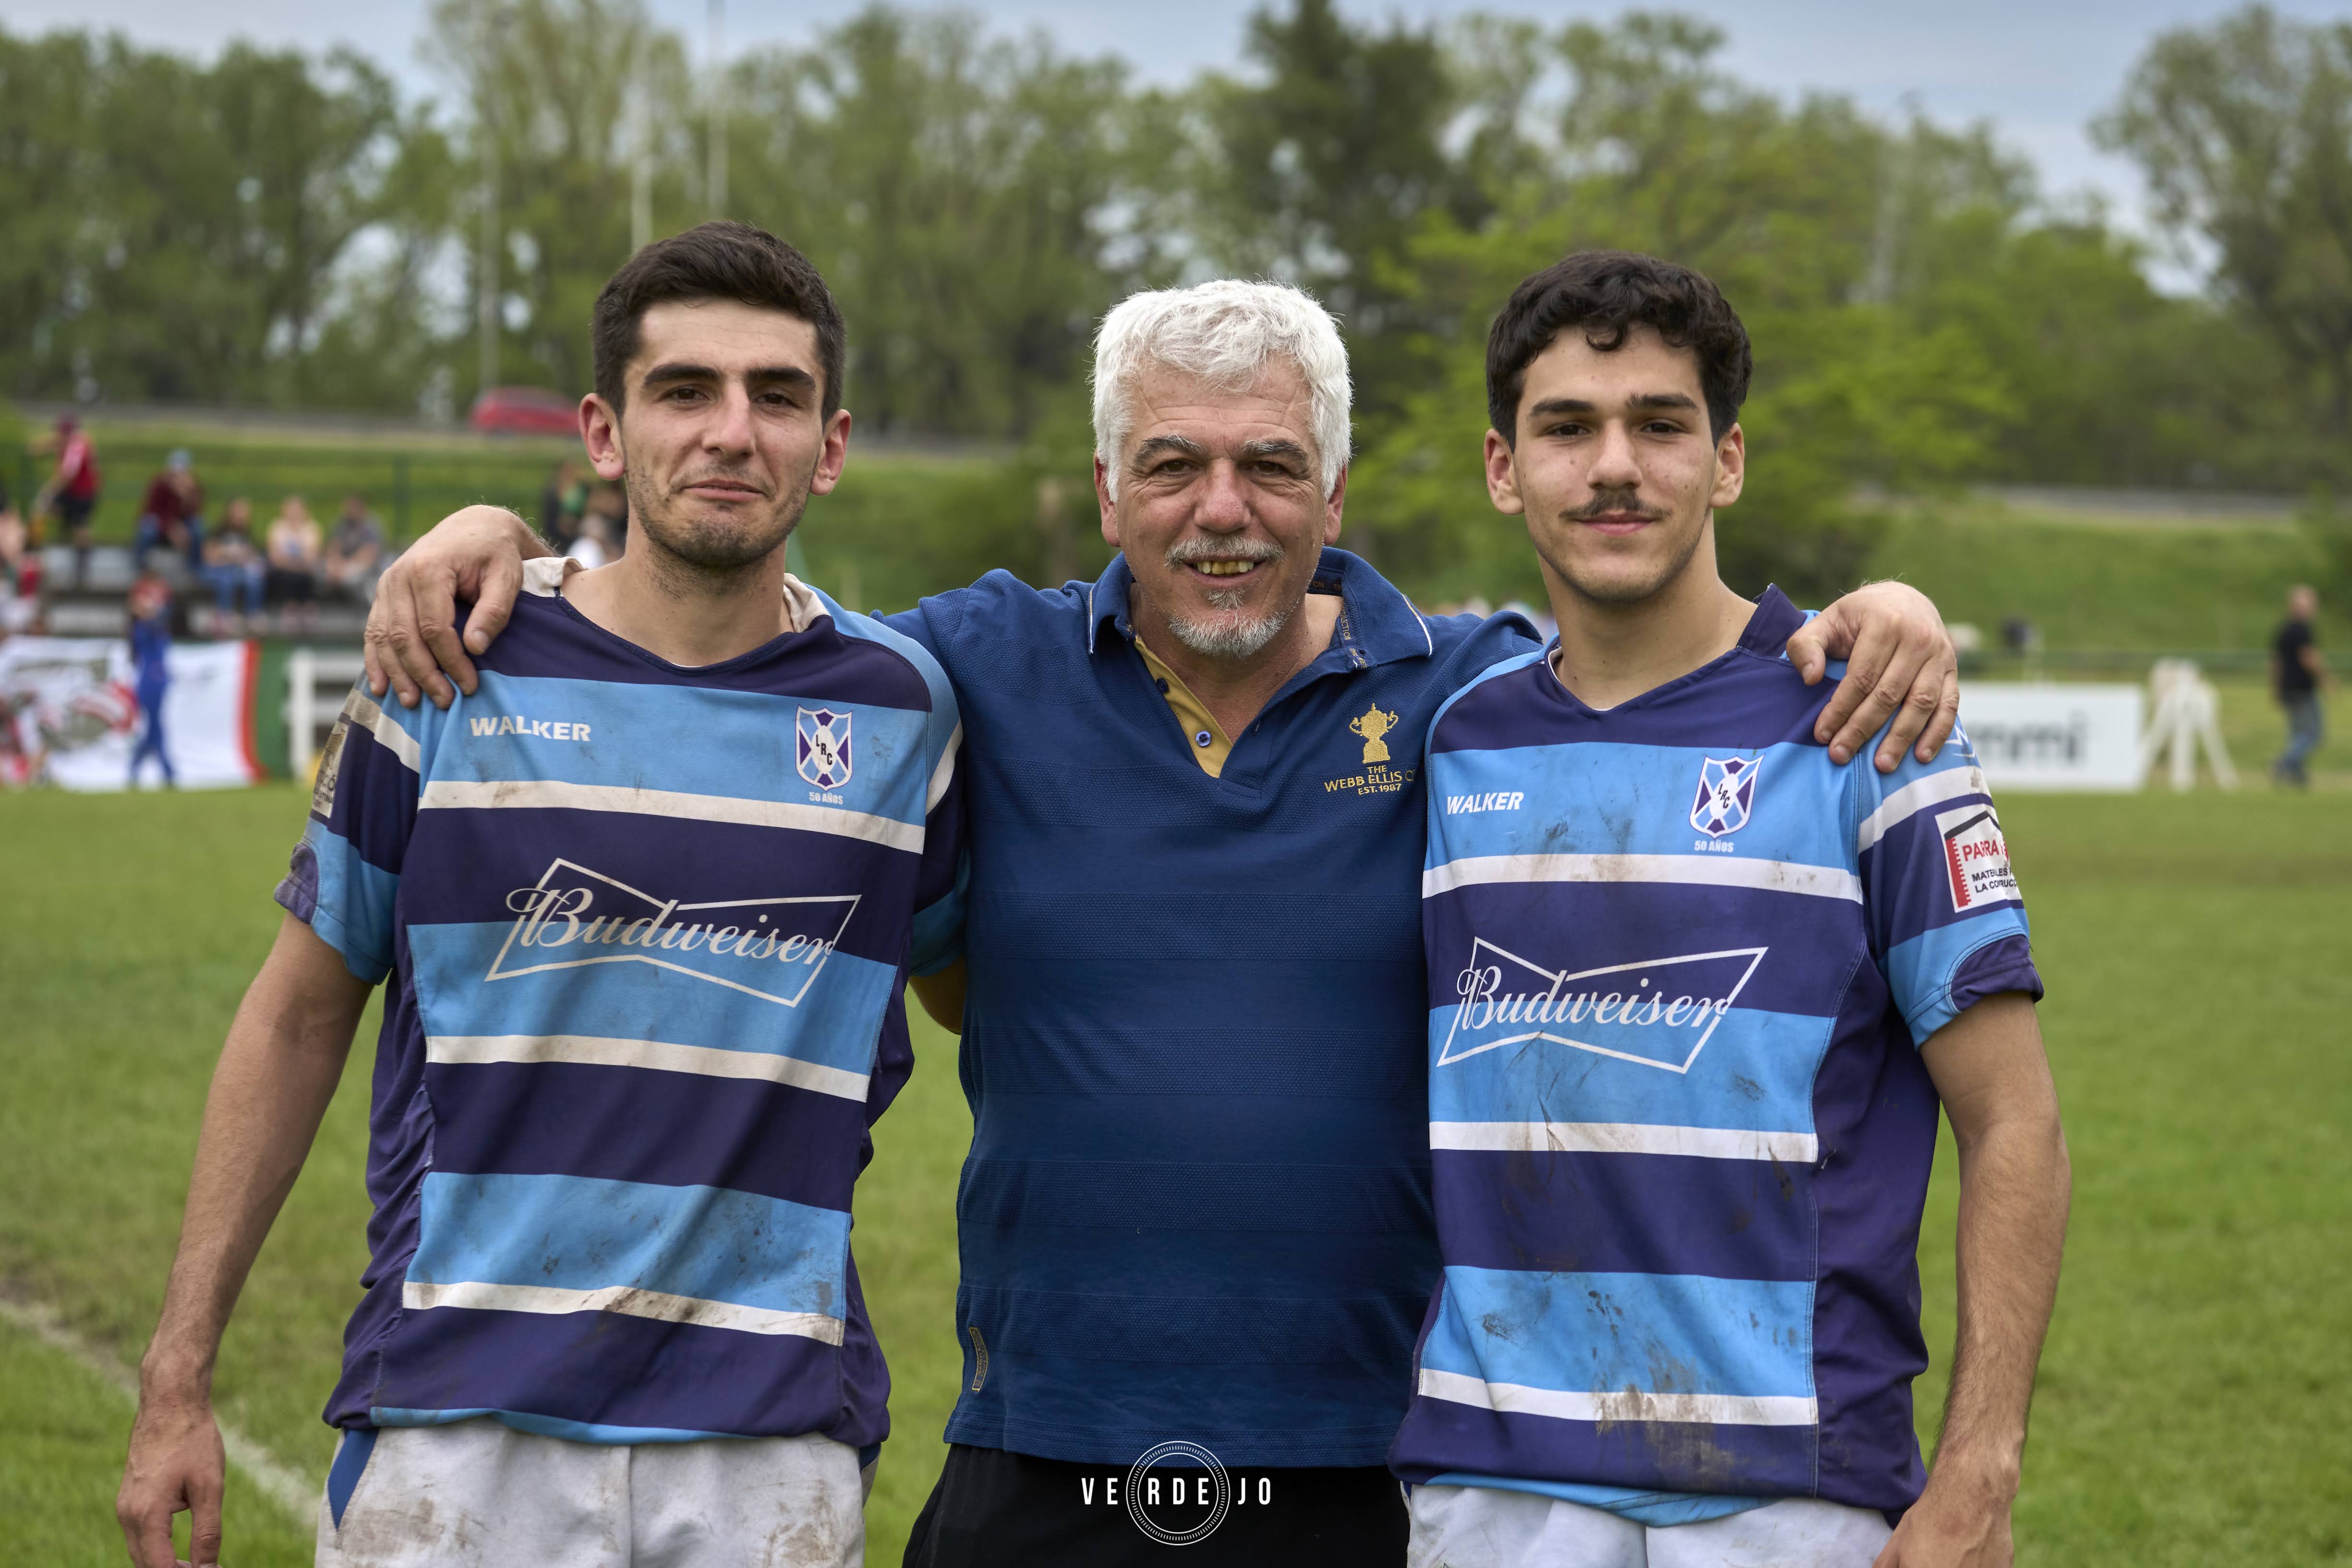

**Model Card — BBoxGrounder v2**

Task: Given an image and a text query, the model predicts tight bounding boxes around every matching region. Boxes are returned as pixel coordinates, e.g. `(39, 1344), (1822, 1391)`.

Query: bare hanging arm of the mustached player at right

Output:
(1877, 992), (2075, 1568)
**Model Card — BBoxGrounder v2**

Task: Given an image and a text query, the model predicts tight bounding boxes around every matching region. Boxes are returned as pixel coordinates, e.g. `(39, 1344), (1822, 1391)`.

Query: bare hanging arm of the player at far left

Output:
(115, 917), (372, 1568)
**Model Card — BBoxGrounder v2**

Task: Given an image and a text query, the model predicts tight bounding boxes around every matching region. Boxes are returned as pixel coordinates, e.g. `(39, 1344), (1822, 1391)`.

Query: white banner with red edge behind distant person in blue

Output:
(0, 637), (266, 790)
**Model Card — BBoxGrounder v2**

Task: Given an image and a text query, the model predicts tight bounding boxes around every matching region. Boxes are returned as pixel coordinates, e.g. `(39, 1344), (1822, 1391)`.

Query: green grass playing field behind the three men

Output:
(0, 787), (2352, 1568)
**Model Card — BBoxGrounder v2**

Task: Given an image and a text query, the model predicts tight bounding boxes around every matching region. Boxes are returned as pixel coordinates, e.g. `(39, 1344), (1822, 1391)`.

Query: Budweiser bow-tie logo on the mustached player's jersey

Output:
(1437, 938), (1769, 1072)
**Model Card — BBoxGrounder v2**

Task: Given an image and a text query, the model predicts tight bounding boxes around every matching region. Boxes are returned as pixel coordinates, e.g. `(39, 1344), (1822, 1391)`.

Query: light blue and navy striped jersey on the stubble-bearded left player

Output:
(277, 571), (962, 1448)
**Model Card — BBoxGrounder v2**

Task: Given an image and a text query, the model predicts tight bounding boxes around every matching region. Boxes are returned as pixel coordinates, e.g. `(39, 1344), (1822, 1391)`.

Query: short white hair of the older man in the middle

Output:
(1094, 277), (1348, 501)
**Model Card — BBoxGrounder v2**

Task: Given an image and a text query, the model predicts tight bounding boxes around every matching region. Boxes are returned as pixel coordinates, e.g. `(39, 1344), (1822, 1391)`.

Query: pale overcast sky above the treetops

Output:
(18, 0), (2352, 255)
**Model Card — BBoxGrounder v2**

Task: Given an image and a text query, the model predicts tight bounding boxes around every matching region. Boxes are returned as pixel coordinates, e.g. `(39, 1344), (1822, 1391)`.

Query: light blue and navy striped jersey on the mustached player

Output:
(1390, 590), (2041, 1523)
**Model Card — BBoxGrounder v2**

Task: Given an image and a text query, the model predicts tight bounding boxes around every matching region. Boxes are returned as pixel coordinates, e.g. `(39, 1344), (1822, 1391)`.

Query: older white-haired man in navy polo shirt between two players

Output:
(369, 282), (1957, 1568)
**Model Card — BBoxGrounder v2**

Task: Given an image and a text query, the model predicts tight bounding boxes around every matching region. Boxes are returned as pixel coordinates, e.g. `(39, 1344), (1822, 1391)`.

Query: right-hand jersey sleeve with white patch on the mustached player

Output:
(1846, 729), (2041, 1044)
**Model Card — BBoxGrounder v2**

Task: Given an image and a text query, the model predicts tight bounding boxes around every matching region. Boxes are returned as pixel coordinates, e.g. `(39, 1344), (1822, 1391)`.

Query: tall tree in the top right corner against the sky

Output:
(2096, 5), (2352, 440)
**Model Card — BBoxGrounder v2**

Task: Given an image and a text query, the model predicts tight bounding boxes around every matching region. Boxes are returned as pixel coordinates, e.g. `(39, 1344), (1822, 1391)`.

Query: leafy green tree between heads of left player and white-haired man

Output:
(729, 7), (1171, 440)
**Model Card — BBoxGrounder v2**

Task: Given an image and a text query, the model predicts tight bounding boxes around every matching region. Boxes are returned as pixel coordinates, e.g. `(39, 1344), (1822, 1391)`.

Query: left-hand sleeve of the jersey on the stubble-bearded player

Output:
(275, 687), (437, 985)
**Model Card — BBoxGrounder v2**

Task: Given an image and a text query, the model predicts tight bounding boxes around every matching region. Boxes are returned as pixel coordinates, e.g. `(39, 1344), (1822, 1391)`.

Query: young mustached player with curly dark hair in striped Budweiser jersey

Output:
(1392, 252), (2070, 1568)
